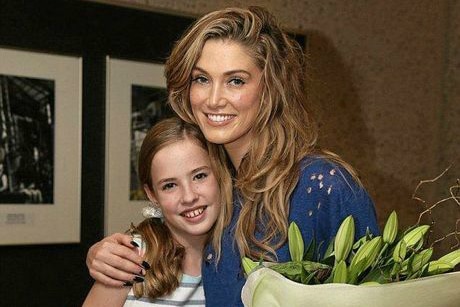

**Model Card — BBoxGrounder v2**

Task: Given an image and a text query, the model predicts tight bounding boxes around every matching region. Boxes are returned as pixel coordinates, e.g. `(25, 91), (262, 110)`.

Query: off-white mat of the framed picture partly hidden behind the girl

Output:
(104, 57), (166, 235)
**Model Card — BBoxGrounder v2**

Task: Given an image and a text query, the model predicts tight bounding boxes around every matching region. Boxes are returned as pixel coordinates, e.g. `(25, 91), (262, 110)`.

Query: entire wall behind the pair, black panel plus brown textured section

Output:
(0, 0), (460, 306)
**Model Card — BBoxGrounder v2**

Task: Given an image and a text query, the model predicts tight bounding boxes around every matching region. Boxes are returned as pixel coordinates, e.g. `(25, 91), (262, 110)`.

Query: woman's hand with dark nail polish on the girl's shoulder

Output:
(86, 233), (150, 287)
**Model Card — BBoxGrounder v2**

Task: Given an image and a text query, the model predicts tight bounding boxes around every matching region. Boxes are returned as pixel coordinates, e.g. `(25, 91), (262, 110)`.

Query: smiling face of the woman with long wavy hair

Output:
(190, 39), (262, 160)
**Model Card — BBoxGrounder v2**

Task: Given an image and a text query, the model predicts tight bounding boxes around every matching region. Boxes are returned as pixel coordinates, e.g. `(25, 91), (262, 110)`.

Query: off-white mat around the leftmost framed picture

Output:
(0, 48), (82, 245)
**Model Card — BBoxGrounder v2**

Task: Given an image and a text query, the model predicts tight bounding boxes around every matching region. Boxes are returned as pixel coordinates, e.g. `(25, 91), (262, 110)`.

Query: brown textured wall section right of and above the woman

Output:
(88, 0), (460, 253)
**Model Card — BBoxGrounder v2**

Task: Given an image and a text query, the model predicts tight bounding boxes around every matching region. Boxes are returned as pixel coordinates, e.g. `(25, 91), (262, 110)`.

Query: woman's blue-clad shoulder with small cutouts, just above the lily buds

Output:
(290, 156), (378, 238)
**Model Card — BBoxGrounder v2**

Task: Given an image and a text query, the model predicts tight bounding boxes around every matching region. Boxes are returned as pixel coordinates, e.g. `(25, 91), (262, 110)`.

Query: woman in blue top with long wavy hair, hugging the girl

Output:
(88, 7), (379, 306)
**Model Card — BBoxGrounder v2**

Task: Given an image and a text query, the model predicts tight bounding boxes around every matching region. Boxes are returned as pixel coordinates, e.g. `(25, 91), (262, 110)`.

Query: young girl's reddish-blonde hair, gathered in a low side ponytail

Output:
(131, 118), (232, 298)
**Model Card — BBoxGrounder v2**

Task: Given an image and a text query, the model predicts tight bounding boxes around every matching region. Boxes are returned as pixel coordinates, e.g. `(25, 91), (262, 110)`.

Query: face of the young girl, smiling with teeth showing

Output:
(145, 139), (220, 246)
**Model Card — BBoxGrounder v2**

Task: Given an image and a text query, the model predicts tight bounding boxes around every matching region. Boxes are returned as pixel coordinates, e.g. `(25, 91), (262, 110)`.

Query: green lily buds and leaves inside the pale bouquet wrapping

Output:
(242, 212), (460, 285)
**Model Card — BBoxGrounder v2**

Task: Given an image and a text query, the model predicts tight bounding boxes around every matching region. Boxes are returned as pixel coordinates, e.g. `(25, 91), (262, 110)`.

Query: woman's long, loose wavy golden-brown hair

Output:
(165, 7), (360, 260)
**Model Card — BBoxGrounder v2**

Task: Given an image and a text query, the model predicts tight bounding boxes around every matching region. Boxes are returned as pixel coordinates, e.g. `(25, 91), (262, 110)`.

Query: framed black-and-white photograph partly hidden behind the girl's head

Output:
(105, 57), (173, 234)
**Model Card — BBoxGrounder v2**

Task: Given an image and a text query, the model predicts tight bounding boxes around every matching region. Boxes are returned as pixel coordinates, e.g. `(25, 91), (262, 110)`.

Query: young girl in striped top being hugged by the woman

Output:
(84, 118), (228, 307)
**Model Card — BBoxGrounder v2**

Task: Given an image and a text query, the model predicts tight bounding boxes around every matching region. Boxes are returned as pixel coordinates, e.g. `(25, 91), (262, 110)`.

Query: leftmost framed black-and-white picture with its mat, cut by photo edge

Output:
(0, 48), (82, 245)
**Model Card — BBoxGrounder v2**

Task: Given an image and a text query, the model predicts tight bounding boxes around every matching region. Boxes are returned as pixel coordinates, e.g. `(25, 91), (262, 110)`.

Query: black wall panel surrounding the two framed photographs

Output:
(0, 0), (192, 307)
